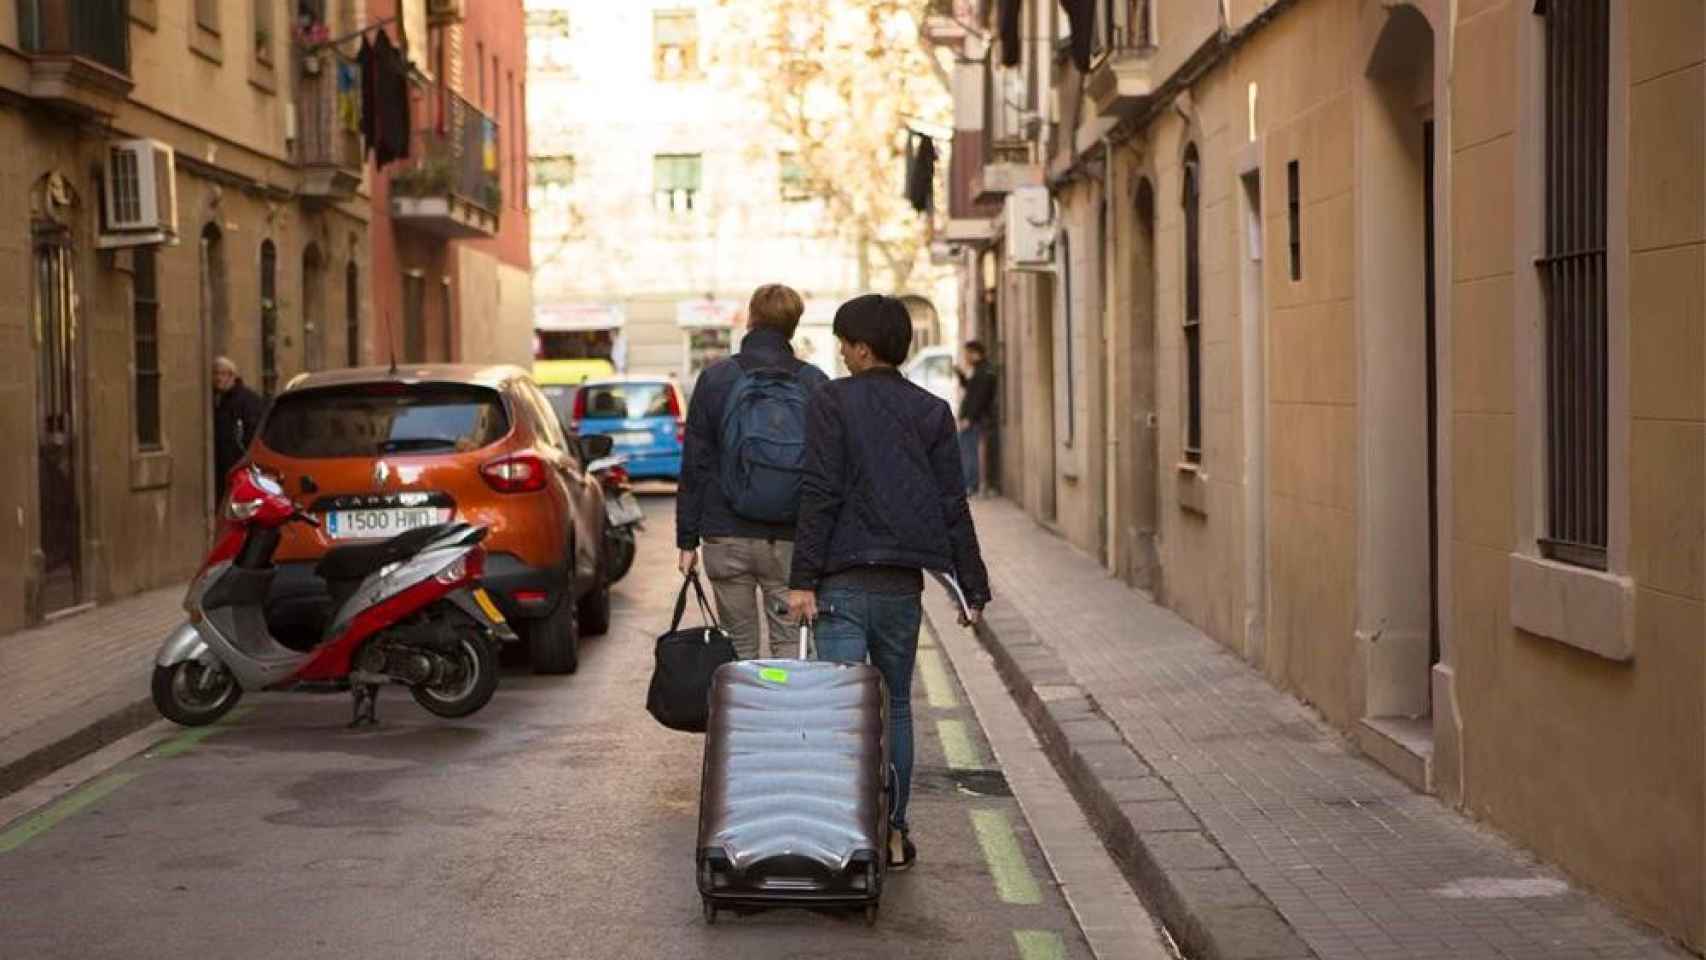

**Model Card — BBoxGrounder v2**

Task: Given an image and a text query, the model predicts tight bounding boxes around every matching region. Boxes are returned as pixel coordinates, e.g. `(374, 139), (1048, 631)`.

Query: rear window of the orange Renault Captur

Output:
(261, 384), (510, 459)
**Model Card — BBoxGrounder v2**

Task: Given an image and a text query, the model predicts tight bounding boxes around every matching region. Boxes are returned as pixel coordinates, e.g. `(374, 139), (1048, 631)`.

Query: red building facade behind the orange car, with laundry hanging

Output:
(366, 0), (532, 363)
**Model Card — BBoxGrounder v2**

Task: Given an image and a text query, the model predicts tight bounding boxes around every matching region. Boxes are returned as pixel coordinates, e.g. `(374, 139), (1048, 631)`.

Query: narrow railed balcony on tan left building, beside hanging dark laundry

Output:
(295, 48), (365, 201)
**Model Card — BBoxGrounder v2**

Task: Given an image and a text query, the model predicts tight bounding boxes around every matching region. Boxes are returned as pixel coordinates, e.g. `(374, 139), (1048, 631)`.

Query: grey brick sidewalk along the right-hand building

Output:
(976, 500), (1687, 960)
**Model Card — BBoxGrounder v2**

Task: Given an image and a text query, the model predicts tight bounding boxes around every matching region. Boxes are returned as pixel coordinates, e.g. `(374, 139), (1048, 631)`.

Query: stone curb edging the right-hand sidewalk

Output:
(978, 610), (1317, 960)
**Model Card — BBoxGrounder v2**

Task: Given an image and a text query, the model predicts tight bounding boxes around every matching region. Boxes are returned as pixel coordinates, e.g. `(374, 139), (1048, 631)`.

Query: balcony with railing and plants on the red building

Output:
(391, 89), (503, 239)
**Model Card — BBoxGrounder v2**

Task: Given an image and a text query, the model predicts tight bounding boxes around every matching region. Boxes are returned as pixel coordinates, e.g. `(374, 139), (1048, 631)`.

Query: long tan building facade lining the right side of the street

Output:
(928, 0), (1706, 950)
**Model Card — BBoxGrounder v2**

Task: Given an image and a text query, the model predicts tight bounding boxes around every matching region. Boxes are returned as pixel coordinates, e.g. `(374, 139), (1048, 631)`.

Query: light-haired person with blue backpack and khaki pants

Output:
(676, 283), (829, 658)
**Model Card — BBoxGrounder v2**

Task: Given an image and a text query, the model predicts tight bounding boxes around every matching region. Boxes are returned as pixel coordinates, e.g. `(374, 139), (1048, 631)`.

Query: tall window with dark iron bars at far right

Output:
(1535, 0), (1610, 570)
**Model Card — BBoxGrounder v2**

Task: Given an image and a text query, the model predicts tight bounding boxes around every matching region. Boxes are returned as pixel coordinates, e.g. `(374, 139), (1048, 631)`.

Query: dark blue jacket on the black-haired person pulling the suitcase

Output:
(788, 367), (989, 607)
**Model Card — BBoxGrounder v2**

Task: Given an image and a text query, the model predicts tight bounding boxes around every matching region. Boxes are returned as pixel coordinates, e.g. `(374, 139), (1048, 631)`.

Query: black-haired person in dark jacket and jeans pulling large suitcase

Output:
(788, 293), (989, 870)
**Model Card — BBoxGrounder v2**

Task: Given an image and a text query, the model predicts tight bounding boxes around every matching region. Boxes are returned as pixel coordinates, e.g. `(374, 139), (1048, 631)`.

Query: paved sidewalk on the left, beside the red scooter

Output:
(0, 587), (184, 796)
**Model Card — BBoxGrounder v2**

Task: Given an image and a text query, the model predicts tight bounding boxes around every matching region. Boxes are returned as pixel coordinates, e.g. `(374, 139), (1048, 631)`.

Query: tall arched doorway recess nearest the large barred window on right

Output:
(1356, 3), (1438, 742)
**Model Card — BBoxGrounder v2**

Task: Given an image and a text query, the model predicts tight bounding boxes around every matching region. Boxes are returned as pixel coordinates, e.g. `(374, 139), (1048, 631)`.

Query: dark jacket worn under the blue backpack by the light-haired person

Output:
(676, 327), (829, 551)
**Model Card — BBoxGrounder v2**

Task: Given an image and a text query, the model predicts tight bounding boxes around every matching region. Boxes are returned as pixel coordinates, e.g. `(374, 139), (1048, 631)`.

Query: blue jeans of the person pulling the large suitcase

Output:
(815, 588), (925, 830)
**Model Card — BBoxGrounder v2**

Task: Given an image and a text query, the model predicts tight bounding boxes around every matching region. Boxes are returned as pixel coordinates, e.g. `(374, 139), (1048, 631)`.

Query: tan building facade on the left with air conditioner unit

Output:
(0, 0), (370, 633)
